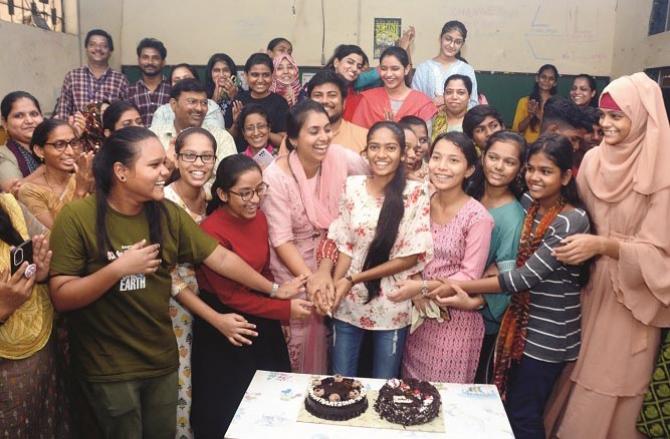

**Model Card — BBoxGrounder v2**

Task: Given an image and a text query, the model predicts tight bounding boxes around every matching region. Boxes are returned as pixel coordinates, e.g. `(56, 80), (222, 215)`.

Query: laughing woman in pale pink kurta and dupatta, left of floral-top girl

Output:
(262, 100), (367, 374)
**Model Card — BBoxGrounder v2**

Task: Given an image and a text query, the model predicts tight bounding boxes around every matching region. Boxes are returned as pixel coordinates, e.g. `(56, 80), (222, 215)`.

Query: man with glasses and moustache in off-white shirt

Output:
(150, 78), (237, 169)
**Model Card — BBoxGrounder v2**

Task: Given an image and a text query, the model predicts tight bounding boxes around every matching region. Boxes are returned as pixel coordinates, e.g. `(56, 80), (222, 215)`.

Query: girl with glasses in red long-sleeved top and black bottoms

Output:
(191, 155), (311, 438)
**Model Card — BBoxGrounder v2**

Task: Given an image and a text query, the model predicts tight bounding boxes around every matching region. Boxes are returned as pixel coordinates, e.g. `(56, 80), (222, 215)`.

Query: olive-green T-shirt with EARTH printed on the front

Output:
(51, 195), (217, 382)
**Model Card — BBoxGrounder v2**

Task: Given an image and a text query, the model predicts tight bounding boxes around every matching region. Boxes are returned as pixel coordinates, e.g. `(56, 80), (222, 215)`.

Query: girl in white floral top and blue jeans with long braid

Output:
(328, 121), (433, 378)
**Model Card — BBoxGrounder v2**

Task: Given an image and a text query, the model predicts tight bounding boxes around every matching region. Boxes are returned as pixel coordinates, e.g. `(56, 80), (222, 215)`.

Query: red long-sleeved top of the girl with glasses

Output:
(197, 208), (291, 321)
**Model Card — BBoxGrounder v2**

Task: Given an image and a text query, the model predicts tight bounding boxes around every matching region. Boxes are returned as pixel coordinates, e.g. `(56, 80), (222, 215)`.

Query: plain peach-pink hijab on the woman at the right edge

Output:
(580, 73), (670, 202)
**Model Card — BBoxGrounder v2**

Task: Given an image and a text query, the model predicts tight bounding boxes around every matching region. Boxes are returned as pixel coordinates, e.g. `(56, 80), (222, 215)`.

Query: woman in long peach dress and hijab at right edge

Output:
(545, 73), (670, 439)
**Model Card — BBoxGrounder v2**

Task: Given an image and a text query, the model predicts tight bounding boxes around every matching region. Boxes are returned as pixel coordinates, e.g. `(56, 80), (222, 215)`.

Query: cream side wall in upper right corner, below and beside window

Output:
(611, 0), (670, 78)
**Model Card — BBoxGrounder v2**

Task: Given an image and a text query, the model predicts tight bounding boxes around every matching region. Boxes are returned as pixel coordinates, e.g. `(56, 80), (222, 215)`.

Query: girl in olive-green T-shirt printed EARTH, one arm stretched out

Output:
(49, 127), (304, 438)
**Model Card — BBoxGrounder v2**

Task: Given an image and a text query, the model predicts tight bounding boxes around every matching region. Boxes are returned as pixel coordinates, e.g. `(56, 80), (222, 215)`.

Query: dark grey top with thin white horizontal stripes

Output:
(498, 194), (590, 363)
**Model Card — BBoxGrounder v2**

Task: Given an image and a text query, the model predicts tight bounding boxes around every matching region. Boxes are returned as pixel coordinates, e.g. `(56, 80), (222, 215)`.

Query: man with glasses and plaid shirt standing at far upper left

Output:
(54, 29), (128, 120)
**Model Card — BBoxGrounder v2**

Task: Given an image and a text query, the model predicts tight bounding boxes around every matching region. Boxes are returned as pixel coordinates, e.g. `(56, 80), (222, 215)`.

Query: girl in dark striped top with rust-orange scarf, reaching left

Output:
(400, 134), (590, 438)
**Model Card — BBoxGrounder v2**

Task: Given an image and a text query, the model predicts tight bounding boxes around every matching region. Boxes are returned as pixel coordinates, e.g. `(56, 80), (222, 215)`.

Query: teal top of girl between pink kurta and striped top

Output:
(482, 200), (526, 334)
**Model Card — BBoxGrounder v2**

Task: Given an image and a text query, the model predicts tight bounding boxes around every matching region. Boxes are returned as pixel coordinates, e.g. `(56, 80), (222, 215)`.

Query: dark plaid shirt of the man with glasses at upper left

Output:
(54, 65), (128, 120)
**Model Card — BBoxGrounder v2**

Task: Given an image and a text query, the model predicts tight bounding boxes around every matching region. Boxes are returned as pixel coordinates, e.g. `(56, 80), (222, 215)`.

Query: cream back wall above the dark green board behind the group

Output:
(119, 0), (617, 75)
